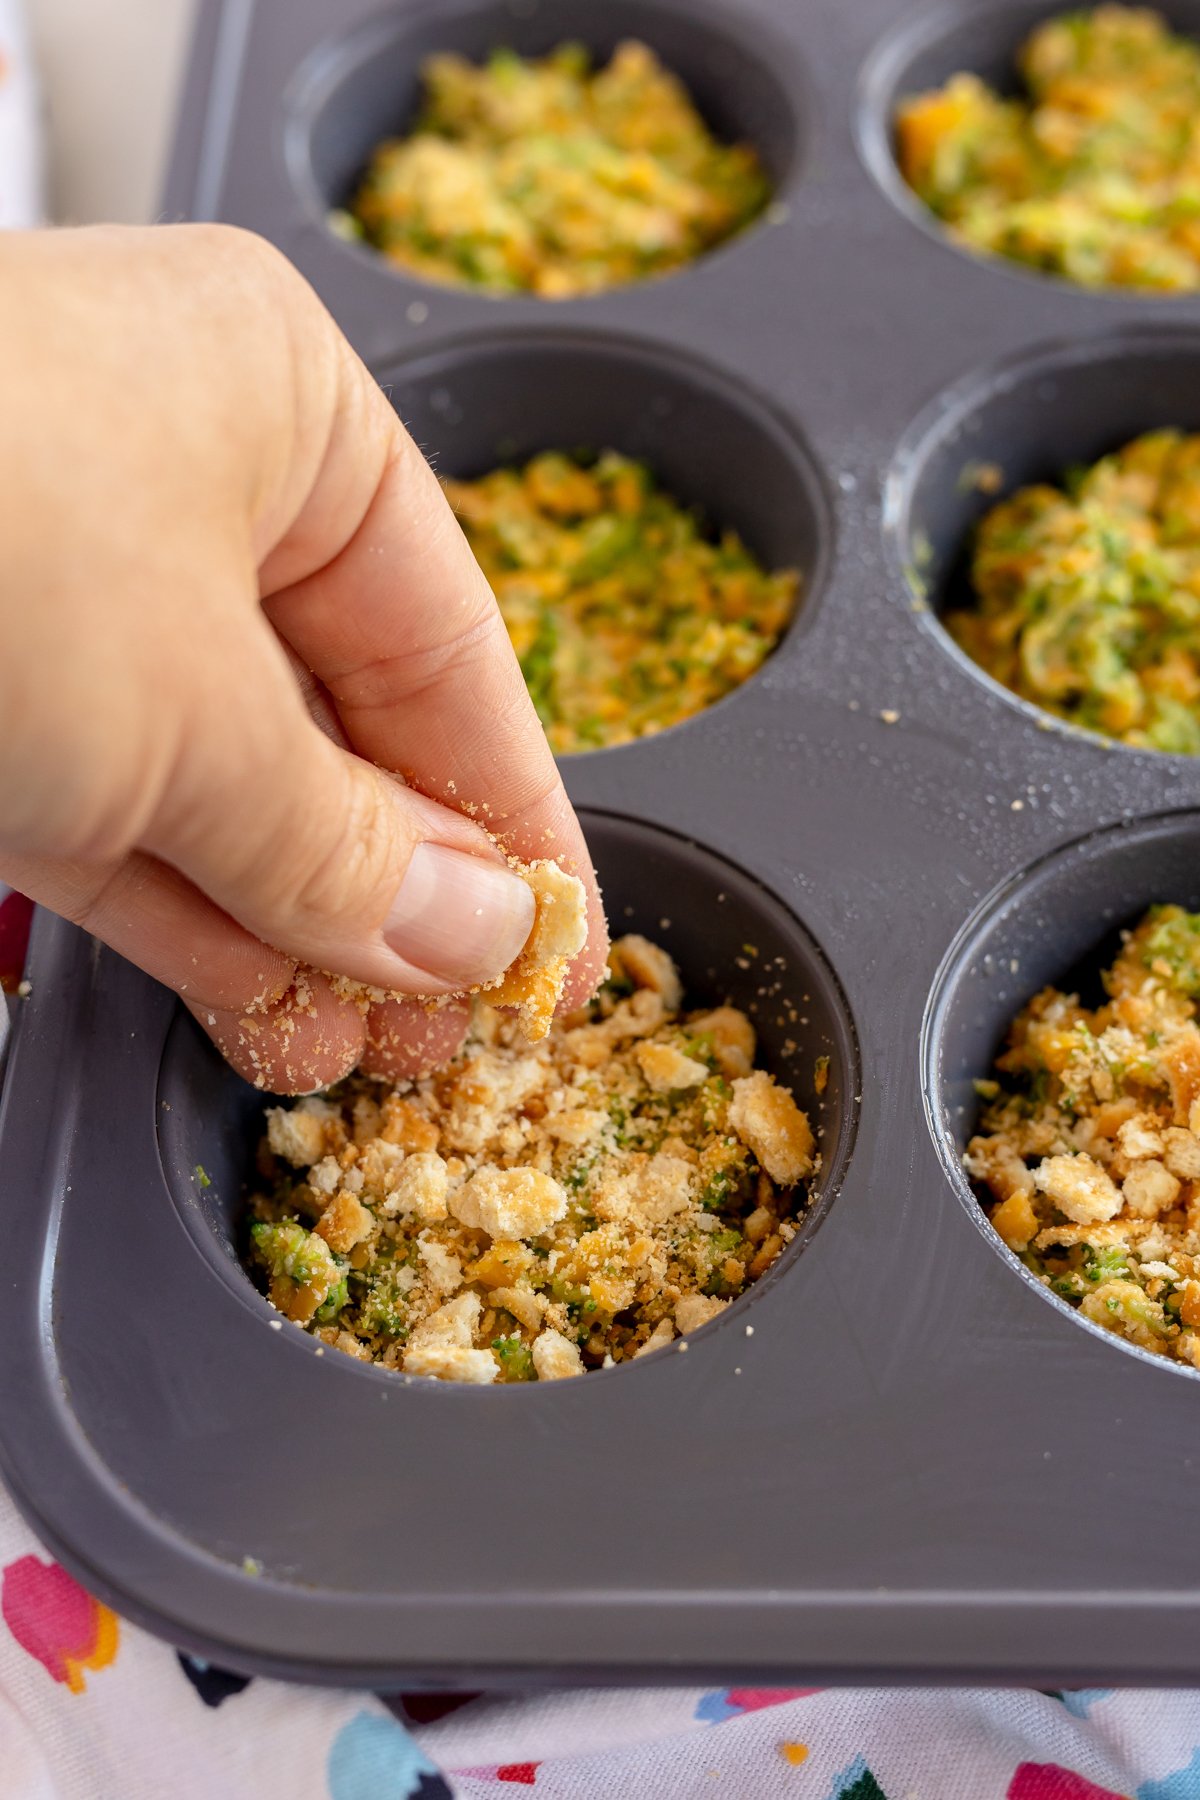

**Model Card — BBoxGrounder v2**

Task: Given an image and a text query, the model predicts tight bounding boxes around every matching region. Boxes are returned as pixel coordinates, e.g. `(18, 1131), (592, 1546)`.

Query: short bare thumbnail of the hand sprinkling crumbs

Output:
(383, 842), (534, 988)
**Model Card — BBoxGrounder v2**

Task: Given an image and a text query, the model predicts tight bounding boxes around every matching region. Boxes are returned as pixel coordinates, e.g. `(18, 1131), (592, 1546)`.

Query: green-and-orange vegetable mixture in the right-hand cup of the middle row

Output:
(945, 430), (1200, 754)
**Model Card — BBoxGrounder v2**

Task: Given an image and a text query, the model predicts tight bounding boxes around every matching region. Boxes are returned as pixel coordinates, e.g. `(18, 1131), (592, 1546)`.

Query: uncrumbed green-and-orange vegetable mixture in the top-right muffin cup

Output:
(896, 5), (1200, 290)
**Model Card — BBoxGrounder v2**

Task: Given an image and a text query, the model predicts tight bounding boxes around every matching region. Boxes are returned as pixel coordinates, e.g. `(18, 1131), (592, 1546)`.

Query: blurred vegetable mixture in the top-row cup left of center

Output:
(331, 41), (770, 299)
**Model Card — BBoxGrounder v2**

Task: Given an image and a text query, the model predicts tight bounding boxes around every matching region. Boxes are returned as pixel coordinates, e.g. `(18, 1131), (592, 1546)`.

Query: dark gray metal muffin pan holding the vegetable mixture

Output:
(0, 0), (1200, 1687)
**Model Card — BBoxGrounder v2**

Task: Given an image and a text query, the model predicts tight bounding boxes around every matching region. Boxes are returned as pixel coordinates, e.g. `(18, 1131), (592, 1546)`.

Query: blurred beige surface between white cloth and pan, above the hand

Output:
(25, 0), (194, 225)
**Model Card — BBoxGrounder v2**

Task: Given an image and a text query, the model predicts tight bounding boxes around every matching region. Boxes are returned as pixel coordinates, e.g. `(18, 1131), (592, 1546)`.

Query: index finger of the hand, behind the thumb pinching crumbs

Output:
(261, 388), (608, 1004)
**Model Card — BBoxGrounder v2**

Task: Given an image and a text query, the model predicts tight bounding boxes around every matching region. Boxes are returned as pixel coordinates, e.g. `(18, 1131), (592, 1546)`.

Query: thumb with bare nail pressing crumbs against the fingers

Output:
(144, 630), (534, 994)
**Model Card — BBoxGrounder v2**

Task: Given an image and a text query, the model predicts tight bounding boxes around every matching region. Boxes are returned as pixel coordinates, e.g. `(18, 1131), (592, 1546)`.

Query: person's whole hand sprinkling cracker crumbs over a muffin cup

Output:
(0, 225), (606, 1093)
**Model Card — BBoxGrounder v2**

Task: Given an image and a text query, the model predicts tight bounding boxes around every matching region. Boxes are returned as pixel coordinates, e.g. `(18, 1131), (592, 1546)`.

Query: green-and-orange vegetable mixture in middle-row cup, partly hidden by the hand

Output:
(444, 450), (799, 754)
